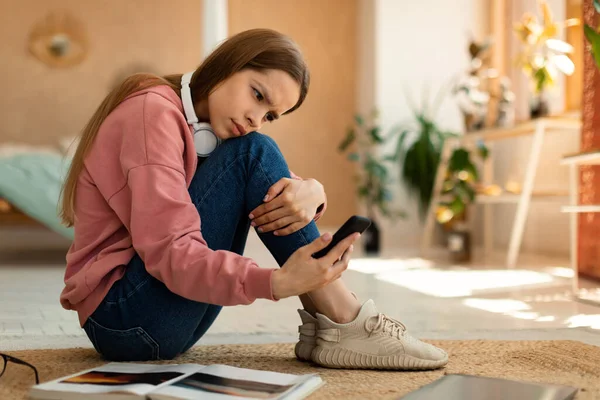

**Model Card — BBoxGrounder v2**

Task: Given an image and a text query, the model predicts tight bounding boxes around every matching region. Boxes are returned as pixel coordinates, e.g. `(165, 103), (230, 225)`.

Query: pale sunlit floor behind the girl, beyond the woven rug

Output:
(0, 233), (600, 351)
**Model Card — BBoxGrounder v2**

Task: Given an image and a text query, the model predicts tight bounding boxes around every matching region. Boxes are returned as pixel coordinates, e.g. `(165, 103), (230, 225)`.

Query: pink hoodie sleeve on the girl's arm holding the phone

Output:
(127, 94), (274, 305)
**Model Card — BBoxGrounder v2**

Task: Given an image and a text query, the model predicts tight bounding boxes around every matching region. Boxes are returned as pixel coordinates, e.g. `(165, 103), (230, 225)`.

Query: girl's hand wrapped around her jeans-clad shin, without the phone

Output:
(249, 178), (325, 236)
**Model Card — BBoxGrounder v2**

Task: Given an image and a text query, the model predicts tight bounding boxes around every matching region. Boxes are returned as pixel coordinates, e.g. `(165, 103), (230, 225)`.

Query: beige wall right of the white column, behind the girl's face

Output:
(228, 0), (357, 226)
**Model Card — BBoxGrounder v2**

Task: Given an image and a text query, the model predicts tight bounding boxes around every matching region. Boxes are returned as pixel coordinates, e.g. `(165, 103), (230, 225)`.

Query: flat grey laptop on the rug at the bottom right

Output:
(401, 374), (579, 400)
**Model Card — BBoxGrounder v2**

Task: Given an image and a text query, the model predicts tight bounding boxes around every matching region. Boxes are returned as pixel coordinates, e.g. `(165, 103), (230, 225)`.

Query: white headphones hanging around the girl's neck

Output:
(181, 72), (221, 157)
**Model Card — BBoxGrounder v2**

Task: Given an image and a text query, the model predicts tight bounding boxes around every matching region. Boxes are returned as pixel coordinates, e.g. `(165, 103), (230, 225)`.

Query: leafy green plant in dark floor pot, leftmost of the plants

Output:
(338, 111), (405, 254)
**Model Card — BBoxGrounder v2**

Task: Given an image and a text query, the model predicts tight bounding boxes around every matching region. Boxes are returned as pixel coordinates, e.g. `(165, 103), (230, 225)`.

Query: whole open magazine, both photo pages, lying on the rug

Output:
(29, 363), (323, 400)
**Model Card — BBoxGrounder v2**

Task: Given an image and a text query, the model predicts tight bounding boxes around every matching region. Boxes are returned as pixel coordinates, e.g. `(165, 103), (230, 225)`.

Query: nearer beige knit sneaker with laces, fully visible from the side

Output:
(312, 300), (448, 370)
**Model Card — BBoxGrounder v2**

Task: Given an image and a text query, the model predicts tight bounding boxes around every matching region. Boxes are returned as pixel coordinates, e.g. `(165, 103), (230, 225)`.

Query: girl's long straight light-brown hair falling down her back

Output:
(59, 29), (310, 227)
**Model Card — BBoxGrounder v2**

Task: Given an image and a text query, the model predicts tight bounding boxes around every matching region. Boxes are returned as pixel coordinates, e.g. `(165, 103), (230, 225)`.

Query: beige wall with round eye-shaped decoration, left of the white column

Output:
(0, 0), (202, 148)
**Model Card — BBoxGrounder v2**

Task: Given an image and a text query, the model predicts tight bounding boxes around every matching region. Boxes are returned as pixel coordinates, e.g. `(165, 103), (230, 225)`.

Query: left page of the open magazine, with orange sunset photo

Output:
(31, 363), (203, 398)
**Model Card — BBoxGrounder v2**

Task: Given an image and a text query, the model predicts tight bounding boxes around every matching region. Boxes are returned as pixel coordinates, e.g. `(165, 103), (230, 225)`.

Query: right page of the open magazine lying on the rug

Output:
(149, 365), (321, 400)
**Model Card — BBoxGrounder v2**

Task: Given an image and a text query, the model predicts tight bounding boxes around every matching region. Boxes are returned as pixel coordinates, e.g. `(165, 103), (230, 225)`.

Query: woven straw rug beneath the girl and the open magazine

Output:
(0, 340), (600, 400)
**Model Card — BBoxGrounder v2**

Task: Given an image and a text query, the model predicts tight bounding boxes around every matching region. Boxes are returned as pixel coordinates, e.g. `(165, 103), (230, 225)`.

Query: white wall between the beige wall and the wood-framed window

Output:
(359, 0), (489, 247)
